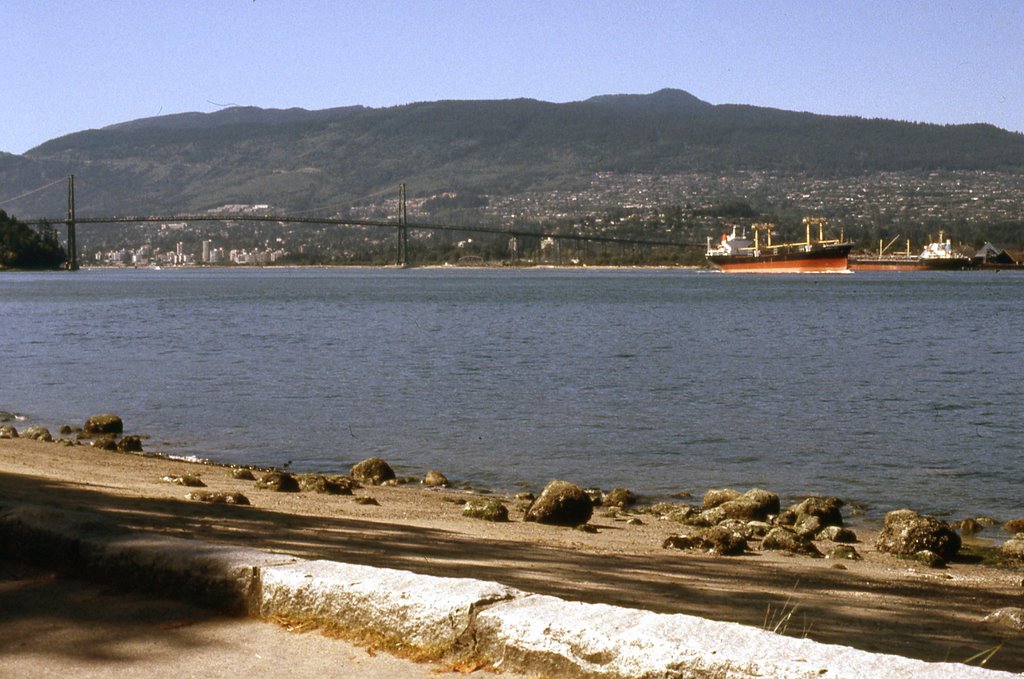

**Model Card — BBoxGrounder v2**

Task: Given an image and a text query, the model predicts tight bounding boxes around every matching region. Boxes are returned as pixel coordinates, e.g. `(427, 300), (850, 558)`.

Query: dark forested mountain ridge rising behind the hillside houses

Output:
(0, 89), (1024, 216)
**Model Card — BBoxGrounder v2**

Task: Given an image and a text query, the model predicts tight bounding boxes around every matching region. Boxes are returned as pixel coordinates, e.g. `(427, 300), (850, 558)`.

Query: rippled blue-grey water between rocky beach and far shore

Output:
(0, 269), (1024, 518)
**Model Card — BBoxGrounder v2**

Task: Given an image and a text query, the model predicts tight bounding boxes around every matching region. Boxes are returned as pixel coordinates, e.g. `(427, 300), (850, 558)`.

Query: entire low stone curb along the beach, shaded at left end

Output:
(0, 505), (1019, 679)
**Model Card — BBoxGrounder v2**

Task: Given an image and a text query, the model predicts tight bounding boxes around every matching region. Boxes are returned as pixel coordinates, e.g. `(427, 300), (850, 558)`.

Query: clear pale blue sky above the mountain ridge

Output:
(0, 0), (1024, 154)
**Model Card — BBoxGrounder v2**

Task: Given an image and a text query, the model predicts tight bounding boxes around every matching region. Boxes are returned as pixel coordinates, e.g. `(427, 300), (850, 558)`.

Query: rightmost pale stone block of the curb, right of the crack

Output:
(475, 595), (1015, 679)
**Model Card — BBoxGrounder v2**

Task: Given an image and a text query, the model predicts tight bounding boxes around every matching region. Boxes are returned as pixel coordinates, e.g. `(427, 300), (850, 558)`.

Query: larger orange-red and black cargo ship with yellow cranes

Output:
(707, 217), (853, 273)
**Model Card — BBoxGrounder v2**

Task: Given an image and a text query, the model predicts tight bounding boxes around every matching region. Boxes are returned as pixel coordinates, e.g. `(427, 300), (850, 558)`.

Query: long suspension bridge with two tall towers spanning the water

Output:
(0, 175), (705, 270)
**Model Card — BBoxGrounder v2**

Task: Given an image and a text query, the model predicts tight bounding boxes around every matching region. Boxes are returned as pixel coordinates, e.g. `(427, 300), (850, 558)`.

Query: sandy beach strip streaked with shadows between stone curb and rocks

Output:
(0, 438), (1024, 672)
